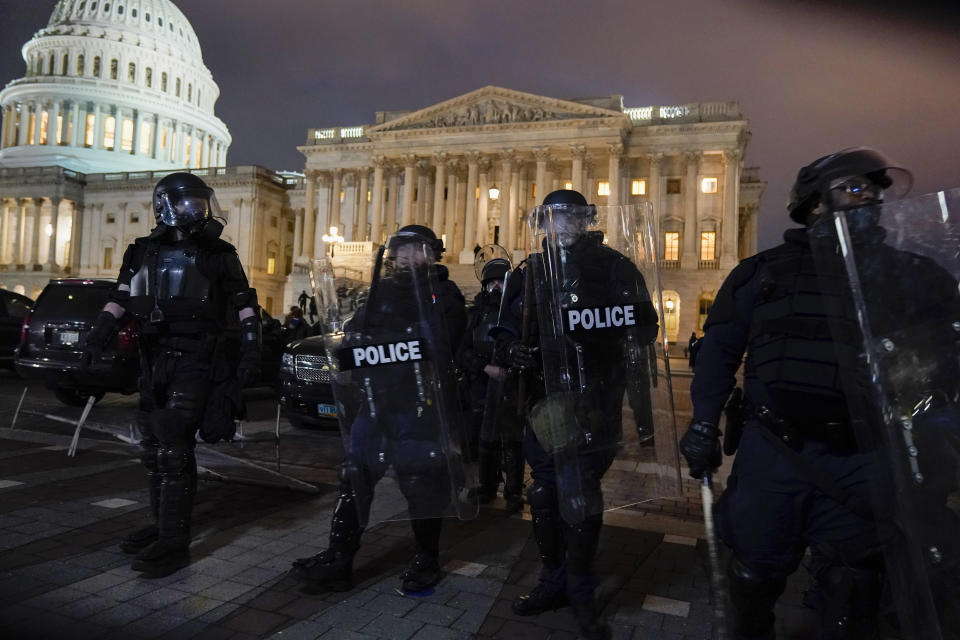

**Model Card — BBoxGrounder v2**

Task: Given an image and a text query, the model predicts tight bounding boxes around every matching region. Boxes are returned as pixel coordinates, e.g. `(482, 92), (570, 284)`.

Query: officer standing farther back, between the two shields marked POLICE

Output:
(457, 258), (524, 511)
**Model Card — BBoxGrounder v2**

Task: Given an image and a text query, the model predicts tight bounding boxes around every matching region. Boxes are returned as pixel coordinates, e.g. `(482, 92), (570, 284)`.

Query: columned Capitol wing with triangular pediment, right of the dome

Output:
(288, 87), (764, 341)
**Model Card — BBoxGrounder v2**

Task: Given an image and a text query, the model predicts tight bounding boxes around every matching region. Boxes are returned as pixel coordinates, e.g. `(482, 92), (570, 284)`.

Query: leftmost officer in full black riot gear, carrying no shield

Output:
(85, 173), (260, 577)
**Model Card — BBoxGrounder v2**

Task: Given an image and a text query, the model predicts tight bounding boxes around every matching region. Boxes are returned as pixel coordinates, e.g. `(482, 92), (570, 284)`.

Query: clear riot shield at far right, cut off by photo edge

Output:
(809, 190), (960, 640)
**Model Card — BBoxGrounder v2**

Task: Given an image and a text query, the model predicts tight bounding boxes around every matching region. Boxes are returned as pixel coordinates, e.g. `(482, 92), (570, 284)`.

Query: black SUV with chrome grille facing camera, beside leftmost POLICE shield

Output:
(279, 336), (337, 429)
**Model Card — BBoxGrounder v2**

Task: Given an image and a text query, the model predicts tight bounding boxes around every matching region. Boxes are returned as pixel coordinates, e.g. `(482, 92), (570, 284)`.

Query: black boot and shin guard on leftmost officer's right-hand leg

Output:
(131, 446), (197, 578)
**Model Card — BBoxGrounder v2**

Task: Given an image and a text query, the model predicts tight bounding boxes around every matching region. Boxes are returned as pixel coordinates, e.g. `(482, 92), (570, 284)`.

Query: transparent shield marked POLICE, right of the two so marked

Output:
(524, 205), (681, 523)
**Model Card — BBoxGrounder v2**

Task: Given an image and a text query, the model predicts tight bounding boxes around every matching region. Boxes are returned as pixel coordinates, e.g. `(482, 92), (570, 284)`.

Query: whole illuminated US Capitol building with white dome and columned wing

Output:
(0, 0), (765, 341)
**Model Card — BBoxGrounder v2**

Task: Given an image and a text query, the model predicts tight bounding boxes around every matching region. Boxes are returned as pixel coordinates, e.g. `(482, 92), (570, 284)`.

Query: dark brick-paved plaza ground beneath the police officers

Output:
(0, 372), (815, 640)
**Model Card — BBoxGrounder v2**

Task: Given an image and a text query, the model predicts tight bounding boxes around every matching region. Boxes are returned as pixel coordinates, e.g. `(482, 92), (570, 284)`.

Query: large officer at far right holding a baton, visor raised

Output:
(680, 148), (922, 639)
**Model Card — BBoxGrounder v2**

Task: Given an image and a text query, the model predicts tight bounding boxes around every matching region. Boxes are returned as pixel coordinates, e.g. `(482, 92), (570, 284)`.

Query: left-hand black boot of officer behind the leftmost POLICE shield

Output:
(291, 476), (363, 594)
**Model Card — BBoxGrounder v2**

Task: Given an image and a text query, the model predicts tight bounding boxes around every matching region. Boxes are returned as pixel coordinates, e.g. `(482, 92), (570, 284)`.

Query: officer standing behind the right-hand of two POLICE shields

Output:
(492, 190), (658, 638)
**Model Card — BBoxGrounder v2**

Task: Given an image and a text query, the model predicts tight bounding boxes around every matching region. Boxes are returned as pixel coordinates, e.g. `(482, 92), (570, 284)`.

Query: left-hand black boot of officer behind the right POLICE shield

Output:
(511, 483), (567, 616)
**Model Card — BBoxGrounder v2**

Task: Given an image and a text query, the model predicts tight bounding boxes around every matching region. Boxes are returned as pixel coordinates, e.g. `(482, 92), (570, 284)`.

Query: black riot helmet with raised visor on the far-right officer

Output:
(787, 147), (913, 225)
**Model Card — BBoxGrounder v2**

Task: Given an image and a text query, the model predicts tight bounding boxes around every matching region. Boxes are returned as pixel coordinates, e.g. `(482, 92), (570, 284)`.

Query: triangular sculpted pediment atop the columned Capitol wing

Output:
(368, 87), (627, 133)
